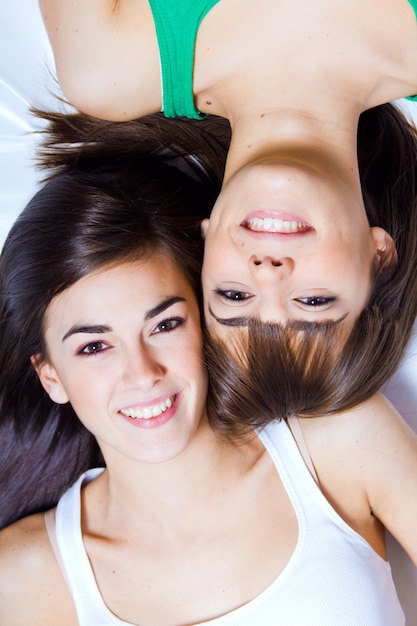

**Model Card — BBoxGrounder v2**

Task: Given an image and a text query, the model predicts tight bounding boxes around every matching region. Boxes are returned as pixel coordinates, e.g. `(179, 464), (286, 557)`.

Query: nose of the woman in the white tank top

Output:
(123, 342), (165, 391)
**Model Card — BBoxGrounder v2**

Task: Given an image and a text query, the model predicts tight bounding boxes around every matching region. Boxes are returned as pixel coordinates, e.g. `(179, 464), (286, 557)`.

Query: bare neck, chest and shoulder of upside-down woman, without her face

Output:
(40, 0), (417, 182)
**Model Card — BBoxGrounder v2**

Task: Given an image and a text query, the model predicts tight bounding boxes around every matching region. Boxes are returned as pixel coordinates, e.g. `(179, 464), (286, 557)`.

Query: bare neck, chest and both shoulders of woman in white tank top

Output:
(0, 396), (417, 626)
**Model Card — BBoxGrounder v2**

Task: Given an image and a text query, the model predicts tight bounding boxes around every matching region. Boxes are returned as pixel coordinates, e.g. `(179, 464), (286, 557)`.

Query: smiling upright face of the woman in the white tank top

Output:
(32, 255), (207, 463)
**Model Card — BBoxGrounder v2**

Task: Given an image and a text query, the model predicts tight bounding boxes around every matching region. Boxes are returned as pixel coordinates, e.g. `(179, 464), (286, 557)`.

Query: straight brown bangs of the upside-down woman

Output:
(206, 312), (399, 438)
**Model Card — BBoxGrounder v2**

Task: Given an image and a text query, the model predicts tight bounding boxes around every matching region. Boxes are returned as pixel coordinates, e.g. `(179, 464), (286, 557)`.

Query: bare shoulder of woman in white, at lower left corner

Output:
(0, 513), (77, 626)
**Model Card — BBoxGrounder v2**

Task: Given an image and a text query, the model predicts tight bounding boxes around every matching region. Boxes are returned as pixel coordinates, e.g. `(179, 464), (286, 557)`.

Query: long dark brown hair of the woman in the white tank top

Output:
(0, 114), (227, 526)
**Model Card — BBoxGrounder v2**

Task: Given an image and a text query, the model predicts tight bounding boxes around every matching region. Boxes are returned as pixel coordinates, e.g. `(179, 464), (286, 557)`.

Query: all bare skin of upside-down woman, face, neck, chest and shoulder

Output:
(40, 0), (417, 333)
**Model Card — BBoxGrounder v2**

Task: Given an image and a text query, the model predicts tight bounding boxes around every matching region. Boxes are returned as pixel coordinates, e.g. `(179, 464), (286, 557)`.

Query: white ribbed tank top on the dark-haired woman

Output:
(48, 421), (405, 626)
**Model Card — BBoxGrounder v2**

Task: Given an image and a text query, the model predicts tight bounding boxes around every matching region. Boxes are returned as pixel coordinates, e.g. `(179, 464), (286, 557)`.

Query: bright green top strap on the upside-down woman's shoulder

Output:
(149, 0), (219, 119)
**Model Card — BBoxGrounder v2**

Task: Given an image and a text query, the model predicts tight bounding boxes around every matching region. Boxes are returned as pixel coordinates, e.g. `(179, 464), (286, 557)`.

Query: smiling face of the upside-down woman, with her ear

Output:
(203, 161), (395, 337)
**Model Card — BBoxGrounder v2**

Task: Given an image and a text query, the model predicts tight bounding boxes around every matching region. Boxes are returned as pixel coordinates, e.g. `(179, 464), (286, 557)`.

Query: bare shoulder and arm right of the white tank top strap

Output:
(300, 394), (417, 565)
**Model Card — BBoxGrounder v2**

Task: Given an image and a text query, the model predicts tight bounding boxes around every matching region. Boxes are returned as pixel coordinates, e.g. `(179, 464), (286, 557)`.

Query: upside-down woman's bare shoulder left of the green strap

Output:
(39, 0), (160, 120)
